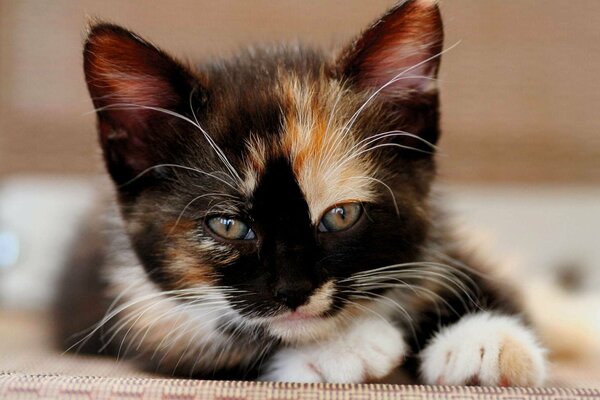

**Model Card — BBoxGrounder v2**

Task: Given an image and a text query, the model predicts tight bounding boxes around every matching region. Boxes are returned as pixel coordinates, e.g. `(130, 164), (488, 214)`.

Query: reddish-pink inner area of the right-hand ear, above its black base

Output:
(338, 0), (444, 97)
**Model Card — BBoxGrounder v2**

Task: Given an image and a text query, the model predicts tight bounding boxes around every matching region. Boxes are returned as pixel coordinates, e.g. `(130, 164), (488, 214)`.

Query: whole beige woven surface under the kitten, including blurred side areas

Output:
(0, 312), (600, 400)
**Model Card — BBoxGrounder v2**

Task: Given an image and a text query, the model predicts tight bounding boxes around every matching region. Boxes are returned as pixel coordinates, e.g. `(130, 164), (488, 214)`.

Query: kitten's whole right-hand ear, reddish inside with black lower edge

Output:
(334, 0), (444, 150)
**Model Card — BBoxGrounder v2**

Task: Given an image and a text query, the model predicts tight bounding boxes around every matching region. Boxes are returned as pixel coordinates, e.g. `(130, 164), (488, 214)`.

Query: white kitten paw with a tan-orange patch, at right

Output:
(421, 312), (546, 386)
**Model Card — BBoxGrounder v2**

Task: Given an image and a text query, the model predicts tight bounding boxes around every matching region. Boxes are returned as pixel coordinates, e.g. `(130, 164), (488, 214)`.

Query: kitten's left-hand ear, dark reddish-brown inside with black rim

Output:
(83, 23), (201, 185)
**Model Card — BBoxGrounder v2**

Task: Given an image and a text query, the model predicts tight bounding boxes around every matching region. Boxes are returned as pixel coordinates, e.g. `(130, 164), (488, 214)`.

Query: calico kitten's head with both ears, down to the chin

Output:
(85, 1), (442, 340)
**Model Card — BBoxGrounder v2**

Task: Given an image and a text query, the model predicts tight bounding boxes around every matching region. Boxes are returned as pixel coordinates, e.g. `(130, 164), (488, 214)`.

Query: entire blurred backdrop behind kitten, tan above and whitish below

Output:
(0, 0), (600, 362)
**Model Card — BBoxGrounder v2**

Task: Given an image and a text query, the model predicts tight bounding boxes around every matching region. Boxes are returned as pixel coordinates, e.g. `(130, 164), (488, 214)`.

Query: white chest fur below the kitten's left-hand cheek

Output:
(101, 235), (262, 371)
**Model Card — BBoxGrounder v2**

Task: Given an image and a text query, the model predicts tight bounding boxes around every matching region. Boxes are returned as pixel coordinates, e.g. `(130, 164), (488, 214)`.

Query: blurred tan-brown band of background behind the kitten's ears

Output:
(0, 0), (600, 180)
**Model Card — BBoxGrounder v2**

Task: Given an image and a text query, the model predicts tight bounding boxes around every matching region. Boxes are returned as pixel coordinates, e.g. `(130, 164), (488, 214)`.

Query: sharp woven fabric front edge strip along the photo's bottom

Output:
(0, 373), (600, 400)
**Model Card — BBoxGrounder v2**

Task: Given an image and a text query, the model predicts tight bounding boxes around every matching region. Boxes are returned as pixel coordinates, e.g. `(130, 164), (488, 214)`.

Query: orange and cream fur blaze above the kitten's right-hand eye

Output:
(281, 76), (375, 224)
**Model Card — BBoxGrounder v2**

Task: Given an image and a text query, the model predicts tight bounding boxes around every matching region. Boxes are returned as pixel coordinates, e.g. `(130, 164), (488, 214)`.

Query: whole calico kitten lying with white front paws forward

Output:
(59, 0), (545, 385)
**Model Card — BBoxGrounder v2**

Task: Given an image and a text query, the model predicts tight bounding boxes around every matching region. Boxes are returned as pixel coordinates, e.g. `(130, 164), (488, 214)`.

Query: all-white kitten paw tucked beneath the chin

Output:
(262, 319), (406, 383)
